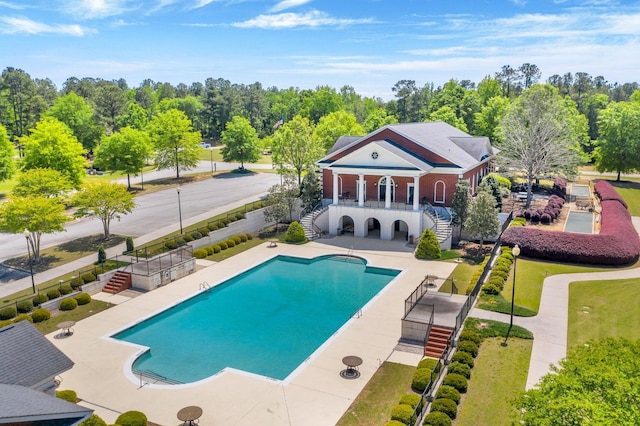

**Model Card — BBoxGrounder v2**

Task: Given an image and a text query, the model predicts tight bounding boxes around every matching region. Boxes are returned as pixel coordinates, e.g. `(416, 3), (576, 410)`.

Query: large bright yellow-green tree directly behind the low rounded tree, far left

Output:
(20, 117), (87, 187)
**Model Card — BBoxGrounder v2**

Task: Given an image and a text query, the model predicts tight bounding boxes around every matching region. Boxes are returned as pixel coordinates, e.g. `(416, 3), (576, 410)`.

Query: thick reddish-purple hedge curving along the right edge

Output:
(502, 181), (640, 265)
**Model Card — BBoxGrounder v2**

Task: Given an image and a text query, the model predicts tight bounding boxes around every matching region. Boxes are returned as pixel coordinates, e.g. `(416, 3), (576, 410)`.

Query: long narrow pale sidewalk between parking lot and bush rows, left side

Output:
(0, 192), (266, 298)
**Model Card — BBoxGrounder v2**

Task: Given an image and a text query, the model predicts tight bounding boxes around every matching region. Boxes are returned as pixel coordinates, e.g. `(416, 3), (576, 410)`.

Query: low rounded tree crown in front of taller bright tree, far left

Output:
(11, 169), (73, 198)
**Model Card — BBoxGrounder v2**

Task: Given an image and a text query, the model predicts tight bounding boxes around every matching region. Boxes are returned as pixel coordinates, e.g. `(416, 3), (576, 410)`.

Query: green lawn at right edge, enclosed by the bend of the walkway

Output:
(567, 278), (640, 348)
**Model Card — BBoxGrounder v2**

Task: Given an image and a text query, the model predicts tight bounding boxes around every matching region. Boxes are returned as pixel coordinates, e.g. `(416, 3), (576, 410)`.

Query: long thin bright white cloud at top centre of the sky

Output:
(231, 10), (373, 29)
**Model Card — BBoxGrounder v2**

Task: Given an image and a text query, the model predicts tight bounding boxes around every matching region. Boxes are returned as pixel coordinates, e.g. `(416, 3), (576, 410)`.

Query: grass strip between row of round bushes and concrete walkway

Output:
(455, 338), (533, 426)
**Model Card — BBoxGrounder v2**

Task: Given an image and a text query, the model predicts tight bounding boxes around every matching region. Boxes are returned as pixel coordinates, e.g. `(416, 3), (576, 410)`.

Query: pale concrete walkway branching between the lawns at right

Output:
(469, 268), (640, 389)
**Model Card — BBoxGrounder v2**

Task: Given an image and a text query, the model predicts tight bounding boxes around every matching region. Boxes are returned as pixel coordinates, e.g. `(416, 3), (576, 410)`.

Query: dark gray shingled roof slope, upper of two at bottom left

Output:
(0, 321), (73, 387)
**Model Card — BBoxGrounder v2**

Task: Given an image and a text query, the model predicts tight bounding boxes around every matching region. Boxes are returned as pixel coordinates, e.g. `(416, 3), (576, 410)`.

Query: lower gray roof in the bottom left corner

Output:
(0, 384), (93, 425)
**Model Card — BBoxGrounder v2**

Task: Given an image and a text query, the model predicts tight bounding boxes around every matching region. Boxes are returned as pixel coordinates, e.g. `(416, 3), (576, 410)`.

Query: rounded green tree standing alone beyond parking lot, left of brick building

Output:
(220, 116), (260, 169)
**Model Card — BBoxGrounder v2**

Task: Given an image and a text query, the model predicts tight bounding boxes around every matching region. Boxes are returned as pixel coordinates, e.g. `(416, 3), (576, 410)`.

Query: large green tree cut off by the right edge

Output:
(594, 102), (640, 181)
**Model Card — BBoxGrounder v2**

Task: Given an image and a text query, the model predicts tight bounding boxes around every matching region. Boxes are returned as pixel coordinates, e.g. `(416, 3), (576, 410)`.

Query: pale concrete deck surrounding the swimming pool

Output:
(47, 237), (456, 426)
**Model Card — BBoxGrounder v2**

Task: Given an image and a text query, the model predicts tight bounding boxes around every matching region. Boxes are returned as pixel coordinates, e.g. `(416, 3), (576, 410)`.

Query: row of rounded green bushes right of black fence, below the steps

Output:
(422, 330), (482, 426)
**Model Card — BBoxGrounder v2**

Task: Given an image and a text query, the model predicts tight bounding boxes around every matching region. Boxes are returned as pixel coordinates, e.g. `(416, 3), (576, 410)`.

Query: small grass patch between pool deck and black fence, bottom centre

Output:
(337, 362), (416, 426)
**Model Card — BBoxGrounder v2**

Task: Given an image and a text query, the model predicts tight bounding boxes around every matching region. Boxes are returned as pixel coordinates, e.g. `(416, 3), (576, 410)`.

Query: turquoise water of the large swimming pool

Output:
(113, 256), (400, 383)
